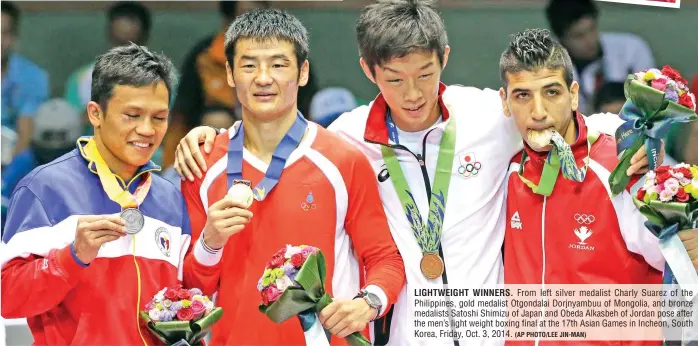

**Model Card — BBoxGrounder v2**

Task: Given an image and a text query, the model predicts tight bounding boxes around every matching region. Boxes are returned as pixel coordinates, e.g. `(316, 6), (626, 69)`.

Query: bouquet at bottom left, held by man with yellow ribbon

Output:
(140, 285), (223, 346)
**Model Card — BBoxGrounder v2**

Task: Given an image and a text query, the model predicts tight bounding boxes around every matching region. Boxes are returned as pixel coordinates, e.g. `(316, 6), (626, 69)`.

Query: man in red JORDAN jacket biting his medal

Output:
(500, 30), (664, 345)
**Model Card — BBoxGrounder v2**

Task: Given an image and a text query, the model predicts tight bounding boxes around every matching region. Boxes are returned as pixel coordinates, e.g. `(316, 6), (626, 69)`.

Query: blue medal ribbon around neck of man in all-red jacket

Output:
(227, 112), (308, 202)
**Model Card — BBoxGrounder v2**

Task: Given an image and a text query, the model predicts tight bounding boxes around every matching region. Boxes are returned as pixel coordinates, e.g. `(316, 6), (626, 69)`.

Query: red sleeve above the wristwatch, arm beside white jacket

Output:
(342, 152), (405, 311)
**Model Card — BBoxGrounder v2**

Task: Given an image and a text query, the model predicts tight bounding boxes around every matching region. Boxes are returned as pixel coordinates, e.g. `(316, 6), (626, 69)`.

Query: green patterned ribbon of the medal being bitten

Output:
(518, 131), (599, 196)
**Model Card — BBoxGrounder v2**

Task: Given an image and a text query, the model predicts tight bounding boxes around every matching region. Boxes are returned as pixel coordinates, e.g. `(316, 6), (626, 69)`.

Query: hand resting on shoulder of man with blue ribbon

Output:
(174, 126), (216, 181)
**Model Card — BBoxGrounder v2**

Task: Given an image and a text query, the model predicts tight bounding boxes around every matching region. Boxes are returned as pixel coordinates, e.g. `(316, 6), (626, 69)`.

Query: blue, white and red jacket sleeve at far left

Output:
(0, 186), (86, 318)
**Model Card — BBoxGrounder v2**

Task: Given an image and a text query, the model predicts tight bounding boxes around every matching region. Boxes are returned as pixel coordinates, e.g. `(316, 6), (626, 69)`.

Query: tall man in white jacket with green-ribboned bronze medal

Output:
(169, 0), (647, 346)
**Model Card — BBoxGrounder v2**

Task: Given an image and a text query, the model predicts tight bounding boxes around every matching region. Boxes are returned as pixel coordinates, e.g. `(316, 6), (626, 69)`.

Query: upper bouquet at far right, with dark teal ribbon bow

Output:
(609, 66), (698, 195)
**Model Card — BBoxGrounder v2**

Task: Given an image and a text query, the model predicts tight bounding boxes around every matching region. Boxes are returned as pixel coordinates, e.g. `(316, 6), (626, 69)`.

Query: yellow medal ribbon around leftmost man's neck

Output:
(78, 138), (152, 209)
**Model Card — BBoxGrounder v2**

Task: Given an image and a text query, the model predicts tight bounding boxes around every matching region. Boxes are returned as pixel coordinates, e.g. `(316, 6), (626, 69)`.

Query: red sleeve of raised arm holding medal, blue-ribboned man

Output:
(182, 167), (222, 295)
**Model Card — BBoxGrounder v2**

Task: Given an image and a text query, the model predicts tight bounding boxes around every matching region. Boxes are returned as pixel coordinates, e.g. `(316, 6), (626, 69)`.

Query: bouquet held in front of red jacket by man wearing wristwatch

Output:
(257, 245), (371, 346)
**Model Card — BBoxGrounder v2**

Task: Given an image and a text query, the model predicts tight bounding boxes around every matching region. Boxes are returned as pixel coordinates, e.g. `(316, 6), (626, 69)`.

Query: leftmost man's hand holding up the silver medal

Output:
(74, 215), (126, 264)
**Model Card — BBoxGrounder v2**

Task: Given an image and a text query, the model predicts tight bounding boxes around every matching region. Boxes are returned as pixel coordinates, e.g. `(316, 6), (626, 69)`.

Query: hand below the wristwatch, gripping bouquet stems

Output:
(319, 298), (377, 338)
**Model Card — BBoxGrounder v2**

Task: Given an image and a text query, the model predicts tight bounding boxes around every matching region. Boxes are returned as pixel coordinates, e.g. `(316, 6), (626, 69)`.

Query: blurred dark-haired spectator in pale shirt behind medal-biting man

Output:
(545, 0), (658, 114)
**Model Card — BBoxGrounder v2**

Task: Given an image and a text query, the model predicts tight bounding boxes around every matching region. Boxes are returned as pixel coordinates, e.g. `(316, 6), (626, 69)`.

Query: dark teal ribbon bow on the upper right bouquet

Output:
(616, 100), (674, 170)
